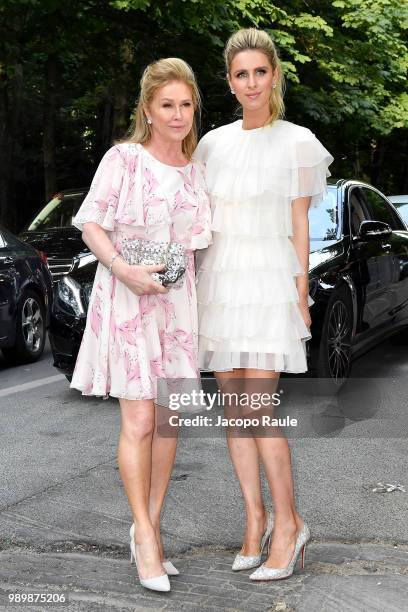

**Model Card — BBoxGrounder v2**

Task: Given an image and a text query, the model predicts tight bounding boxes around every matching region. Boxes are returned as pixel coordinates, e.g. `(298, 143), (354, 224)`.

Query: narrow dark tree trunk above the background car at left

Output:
(43, 54), (57, 200)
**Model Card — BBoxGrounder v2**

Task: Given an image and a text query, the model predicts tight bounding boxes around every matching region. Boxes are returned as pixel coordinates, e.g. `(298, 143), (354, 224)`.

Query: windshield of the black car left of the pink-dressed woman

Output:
(28, 192), (85, 232)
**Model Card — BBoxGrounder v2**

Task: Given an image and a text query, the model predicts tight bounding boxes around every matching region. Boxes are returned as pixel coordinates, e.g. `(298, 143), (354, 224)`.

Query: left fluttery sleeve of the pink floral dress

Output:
(73, 146), (125, 231)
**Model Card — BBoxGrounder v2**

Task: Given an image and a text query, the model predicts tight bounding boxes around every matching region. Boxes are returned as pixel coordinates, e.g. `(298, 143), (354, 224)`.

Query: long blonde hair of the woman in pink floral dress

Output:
(121, 57), (201, 159)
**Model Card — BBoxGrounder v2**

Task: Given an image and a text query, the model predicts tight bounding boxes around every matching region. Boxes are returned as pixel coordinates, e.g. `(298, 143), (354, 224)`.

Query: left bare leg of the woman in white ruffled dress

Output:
(215, 369), (266, 555)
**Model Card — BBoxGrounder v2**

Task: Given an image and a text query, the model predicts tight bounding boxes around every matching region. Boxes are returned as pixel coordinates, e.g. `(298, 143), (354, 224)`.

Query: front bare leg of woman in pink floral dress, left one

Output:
(118, 399), (163, 578)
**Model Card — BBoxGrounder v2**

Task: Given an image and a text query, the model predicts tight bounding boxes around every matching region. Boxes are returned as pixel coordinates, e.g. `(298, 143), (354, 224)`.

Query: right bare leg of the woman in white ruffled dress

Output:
(245, 370), (303, 567)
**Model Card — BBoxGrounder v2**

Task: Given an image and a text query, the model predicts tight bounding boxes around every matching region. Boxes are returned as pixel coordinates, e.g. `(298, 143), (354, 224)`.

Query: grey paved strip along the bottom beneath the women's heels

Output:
(0, 542), (408, 612)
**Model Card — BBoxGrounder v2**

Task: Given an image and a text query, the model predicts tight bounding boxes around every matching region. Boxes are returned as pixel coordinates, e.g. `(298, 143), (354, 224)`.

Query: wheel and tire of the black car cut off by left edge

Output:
(2, 289), (47, 364)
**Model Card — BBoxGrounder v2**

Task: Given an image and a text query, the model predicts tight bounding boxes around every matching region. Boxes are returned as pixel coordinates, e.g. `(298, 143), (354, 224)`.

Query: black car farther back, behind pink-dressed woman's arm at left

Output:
(20, 188), (89, 281)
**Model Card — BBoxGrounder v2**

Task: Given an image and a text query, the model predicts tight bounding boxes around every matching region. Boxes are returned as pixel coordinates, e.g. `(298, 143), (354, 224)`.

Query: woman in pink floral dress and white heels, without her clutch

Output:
(71, 58), (211, 590)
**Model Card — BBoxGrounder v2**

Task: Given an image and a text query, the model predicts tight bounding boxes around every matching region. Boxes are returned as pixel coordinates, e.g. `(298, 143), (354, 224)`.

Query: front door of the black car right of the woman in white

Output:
(347, 185), (384, 338)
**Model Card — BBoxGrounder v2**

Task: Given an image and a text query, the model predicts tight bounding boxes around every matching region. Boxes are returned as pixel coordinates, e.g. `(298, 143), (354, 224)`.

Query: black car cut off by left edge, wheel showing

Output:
(0, 227), (52, 363)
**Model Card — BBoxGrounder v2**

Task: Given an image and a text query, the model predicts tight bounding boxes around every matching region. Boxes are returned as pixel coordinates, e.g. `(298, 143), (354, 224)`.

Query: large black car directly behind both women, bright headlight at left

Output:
(50, 180), (408, 382)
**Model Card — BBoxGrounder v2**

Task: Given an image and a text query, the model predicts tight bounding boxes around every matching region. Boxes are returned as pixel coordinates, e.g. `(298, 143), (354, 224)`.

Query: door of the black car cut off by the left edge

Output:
(0, 230), (16, 344)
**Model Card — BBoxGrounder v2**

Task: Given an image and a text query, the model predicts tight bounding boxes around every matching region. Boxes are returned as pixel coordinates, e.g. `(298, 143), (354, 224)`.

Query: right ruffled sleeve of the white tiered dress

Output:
(292, 130), (333, 207)
